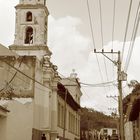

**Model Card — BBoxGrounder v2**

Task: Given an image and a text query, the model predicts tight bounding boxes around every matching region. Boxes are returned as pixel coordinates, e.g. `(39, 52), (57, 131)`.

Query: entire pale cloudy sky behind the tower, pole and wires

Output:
(0, 0), (140, 113)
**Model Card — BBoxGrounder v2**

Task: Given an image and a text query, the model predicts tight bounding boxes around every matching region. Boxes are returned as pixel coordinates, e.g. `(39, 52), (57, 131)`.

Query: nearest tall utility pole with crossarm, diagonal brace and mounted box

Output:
(94, 49), (127, 140)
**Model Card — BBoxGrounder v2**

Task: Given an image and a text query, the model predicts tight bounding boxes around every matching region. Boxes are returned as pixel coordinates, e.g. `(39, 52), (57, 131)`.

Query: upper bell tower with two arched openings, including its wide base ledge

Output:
(9, 0), (51, 58)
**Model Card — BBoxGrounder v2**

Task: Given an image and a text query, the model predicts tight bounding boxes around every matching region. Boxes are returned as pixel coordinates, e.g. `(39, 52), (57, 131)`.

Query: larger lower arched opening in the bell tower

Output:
(25, 27), (33, 44)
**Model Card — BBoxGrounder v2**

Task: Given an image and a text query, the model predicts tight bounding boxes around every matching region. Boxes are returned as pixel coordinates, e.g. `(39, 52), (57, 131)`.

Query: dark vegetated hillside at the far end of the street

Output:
(81, 108), (117, 130)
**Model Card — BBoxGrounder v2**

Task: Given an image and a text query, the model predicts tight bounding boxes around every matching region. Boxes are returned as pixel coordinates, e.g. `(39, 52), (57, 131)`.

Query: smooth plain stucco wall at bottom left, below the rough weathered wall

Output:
(0, 100), (33, 140)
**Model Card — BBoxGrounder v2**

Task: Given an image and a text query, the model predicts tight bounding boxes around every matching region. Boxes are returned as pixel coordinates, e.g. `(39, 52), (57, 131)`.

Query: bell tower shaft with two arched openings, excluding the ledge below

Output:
(14, 0), (49, 46)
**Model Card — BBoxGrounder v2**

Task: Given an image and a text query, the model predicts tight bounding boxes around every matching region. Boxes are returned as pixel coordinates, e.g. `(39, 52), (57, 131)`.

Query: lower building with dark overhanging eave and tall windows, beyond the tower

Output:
(58, 72), (82, 140)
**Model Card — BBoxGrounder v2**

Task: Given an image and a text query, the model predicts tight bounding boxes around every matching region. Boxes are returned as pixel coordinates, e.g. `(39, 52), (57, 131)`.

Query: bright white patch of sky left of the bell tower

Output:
(0, 0), (18, 46)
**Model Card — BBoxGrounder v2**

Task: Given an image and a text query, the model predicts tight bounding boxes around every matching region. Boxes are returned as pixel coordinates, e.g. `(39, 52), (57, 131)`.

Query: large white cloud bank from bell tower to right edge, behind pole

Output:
(48, 16), (140, 112)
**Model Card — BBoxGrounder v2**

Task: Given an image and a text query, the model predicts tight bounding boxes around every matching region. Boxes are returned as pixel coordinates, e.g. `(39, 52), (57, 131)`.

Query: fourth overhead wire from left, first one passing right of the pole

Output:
(121, 0), (132, 61)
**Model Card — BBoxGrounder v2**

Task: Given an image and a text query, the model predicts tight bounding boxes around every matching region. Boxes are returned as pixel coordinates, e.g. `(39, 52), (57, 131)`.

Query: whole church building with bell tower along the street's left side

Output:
(0, 0), (82, 140)
